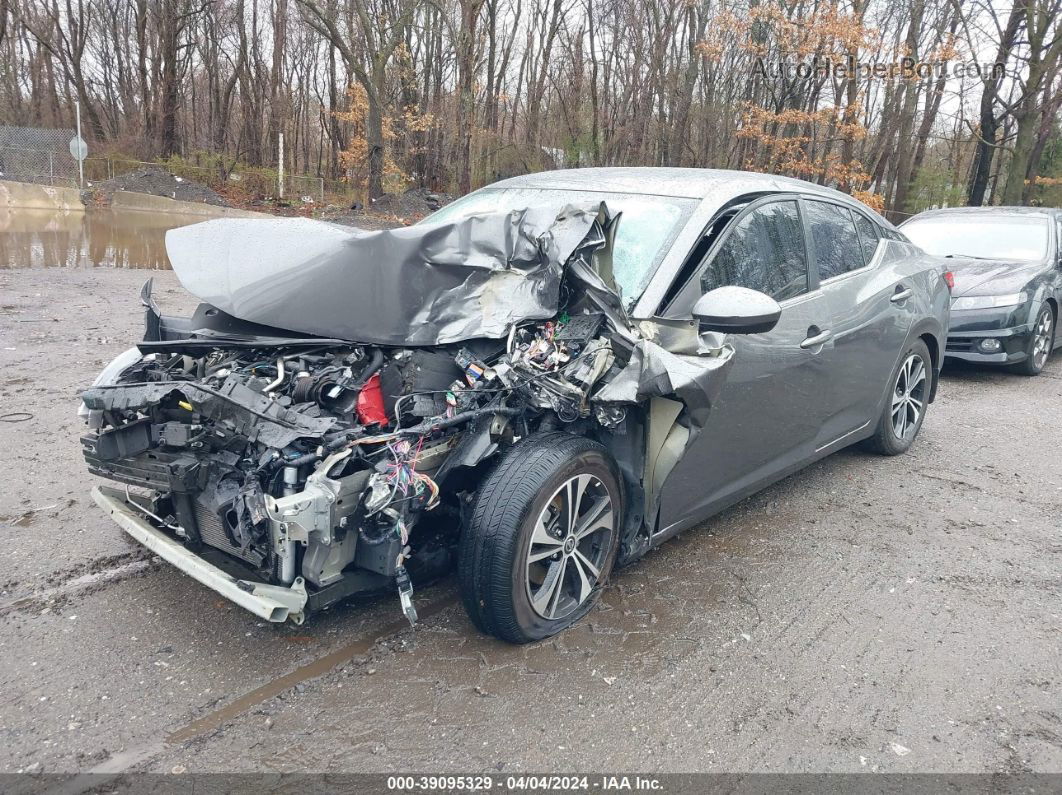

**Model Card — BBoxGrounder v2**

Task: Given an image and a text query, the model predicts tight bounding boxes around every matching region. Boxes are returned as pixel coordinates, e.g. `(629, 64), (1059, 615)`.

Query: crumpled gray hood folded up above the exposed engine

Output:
(166, 204), (609, 345)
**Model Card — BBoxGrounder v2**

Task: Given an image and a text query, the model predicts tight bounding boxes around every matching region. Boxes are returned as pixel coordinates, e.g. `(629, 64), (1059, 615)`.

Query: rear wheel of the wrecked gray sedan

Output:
(867, 340), (933, 455)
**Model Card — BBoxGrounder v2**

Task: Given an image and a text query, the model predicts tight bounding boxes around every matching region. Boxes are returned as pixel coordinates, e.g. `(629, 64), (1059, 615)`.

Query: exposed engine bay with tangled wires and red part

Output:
(83, 301), (627, 621)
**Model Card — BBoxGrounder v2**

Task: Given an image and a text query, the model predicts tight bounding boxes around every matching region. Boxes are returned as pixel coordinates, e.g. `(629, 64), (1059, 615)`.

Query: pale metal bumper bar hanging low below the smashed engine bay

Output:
(92, 479), (307, 624)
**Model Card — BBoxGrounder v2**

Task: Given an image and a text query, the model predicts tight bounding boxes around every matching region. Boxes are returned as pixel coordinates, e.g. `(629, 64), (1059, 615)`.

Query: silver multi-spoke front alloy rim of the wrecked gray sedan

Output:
(527, 474), (616, 621)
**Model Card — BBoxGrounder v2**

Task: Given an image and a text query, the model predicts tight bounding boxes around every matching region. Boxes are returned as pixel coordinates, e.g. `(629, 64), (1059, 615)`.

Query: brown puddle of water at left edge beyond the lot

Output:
(0, 208), (208, 270)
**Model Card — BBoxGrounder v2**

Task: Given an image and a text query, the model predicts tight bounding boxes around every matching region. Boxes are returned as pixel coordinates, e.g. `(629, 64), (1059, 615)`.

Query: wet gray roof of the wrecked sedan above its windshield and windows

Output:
(485, 166), (864, 207)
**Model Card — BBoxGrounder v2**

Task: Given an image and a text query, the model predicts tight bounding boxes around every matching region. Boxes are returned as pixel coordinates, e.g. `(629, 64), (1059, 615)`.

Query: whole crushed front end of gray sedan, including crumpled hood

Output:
(82, 205), (729, 622)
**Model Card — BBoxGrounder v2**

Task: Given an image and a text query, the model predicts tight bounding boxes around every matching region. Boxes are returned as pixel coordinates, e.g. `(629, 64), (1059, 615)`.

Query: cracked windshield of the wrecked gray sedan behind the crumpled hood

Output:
(422, 188), (697, 307)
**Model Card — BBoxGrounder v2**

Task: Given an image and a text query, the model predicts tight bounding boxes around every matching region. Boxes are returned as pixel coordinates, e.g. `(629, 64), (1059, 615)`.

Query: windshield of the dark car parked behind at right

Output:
(903, 214), (1050, 262)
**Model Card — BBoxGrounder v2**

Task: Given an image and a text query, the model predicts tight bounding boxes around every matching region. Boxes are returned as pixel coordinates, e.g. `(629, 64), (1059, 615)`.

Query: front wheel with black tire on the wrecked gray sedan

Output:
(458, 432), (622, 643)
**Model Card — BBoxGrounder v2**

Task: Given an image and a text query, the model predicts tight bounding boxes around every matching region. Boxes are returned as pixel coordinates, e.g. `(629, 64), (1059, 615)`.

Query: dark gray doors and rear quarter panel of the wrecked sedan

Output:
(586, 184), (949, 543)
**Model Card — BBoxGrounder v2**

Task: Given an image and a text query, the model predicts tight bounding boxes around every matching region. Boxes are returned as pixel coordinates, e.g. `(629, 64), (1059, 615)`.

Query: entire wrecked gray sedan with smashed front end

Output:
(82, 169), (948, 642)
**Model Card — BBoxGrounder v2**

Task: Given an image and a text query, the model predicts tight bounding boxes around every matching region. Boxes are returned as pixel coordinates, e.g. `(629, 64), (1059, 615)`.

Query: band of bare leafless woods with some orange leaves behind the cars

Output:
(0, 0), (1062, 211)
